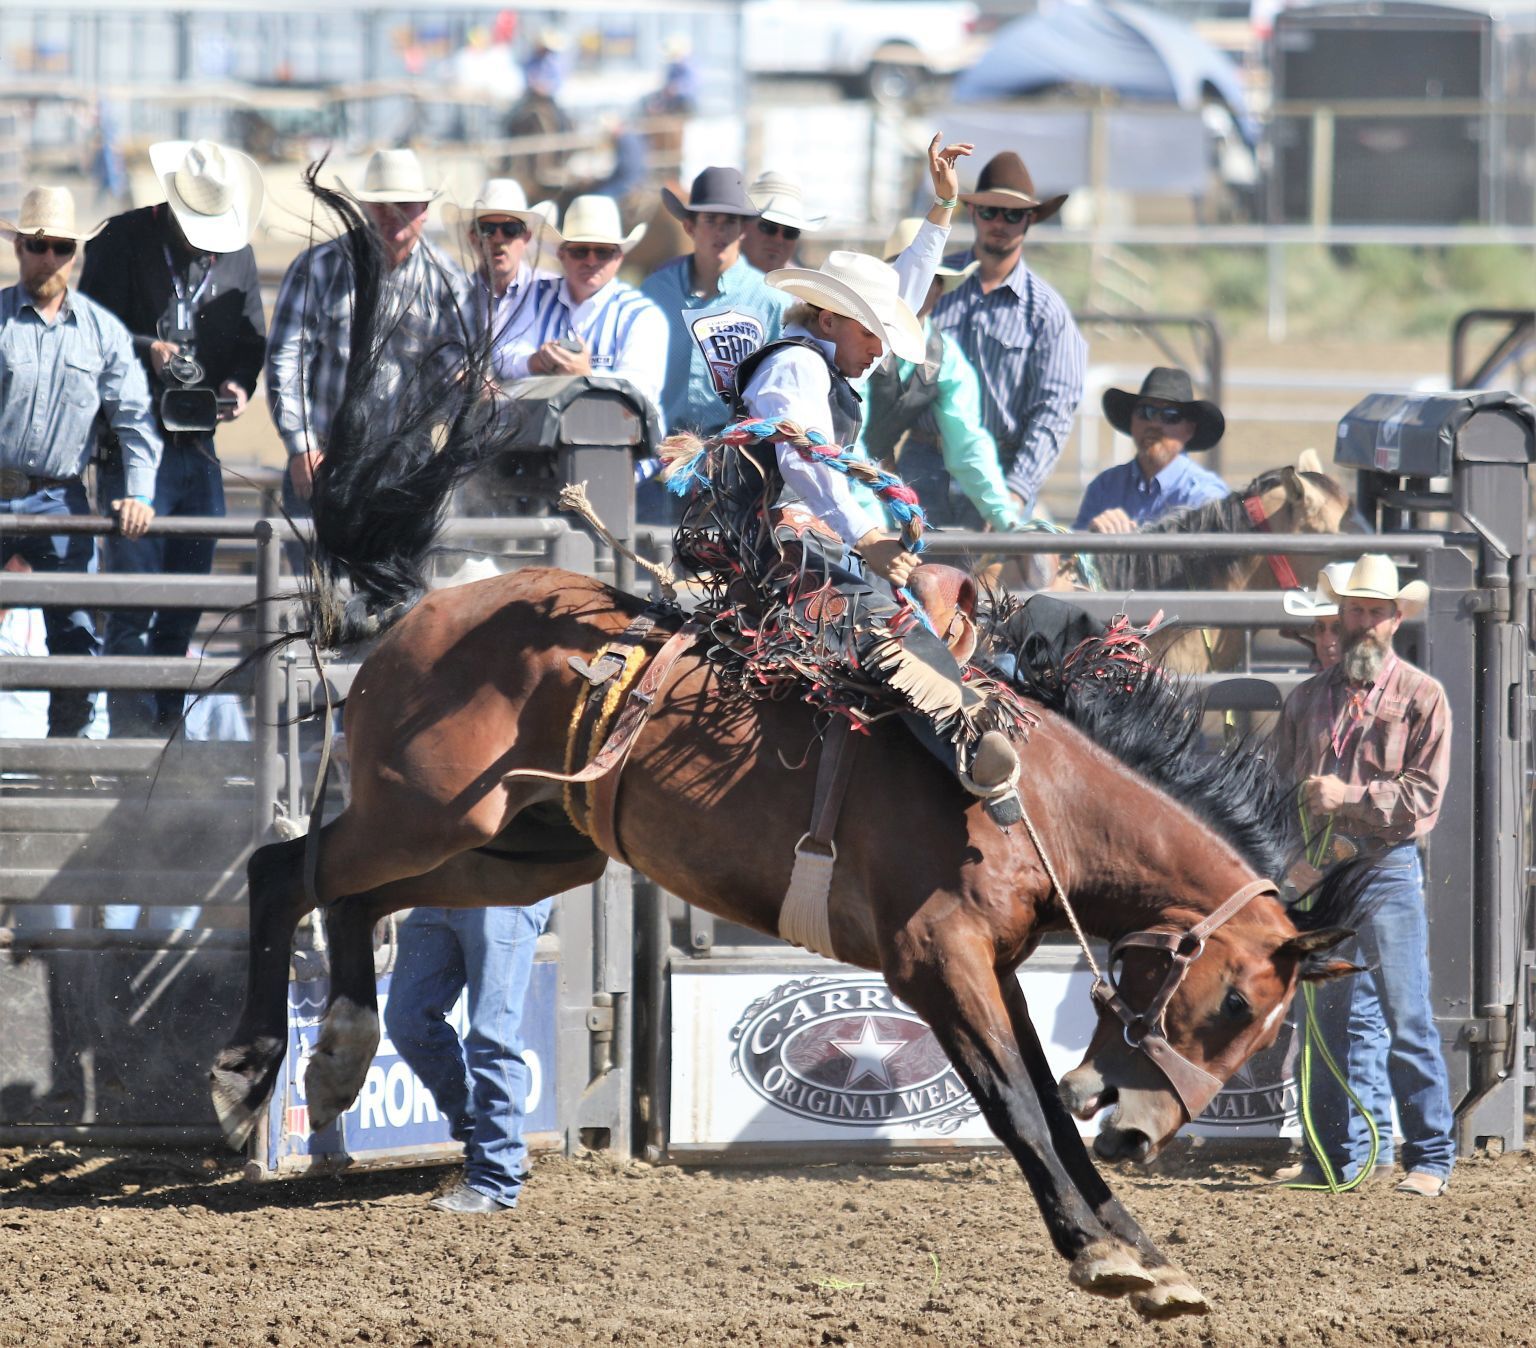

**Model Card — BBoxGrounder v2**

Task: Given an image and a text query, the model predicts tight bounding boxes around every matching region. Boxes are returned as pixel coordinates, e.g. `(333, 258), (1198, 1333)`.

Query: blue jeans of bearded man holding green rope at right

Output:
(1312, 843), (1456, 1178)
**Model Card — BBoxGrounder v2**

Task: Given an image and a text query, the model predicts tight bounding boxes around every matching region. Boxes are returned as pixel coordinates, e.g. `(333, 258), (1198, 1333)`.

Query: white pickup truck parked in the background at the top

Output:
(742, 0), (978, 103)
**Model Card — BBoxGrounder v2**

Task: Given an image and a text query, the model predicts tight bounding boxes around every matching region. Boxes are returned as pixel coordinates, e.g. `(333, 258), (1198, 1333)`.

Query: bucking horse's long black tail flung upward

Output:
(304, 164), (531, 645)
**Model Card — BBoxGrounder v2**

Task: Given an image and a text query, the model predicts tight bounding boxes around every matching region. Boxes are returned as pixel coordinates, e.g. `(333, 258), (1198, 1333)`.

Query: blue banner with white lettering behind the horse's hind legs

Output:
(252, 960), (559, 1176)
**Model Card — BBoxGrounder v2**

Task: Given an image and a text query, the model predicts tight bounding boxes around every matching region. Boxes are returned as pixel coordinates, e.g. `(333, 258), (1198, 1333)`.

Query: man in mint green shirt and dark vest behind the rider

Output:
(863, 216), (1018, 530)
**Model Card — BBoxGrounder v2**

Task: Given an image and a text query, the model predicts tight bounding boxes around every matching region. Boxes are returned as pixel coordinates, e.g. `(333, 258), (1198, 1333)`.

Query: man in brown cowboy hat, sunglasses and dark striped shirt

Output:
(934, 150), (1087, 511)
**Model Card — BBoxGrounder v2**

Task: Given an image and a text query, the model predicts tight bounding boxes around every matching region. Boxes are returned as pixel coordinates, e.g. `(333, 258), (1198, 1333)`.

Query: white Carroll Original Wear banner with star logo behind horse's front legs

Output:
(668, 956), (1296, 1155)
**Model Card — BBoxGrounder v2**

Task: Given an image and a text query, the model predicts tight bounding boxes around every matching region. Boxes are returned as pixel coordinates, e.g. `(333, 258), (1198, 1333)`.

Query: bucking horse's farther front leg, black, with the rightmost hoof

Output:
(1001, 975), (1210, 1319)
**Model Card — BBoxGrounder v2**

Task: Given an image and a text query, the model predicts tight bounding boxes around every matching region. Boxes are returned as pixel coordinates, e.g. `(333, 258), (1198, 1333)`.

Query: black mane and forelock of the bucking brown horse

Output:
(983, 594), (1369, 930)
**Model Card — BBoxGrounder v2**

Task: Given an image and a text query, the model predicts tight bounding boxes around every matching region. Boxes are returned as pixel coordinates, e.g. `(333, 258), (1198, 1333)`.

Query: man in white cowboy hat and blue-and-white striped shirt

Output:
(507, 197), (668, 407)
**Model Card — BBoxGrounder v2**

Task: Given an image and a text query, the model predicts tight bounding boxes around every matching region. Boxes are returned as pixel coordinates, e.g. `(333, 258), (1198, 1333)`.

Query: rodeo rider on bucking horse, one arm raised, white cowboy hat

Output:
(712, 137), (1018, 821)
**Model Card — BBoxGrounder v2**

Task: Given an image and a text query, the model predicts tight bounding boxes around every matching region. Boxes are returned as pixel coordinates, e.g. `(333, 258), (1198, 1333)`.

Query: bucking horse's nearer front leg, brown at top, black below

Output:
(886, 930), (1155, 1296)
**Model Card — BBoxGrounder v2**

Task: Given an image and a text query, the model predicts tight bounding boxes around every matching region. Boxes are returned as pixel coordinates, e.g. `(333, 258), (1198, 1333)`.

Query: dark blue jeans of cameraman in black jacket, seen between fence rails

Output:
(101, 433), (224, 737)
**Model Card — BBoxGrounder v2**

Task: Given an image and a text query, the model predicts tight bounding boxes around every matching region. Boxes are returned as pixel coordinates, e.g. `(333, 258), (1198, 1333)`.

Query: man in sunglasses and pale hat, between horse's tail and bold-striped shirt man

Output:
(449, 178), (558, 379)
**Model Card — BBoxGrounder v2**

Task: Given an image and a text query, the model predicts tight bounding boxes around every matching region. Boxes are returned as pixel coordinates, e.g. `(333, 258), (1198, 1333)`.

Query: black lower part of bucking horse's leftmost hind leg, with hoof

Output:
(209, 838), (310, 1150)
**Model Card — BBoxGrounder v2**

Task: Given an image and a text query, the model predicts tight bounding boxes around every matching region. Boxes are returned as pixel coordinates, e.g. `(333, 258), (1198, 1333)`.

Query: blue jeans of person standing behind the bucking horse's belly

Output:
(384, 898), (554, 1204)
